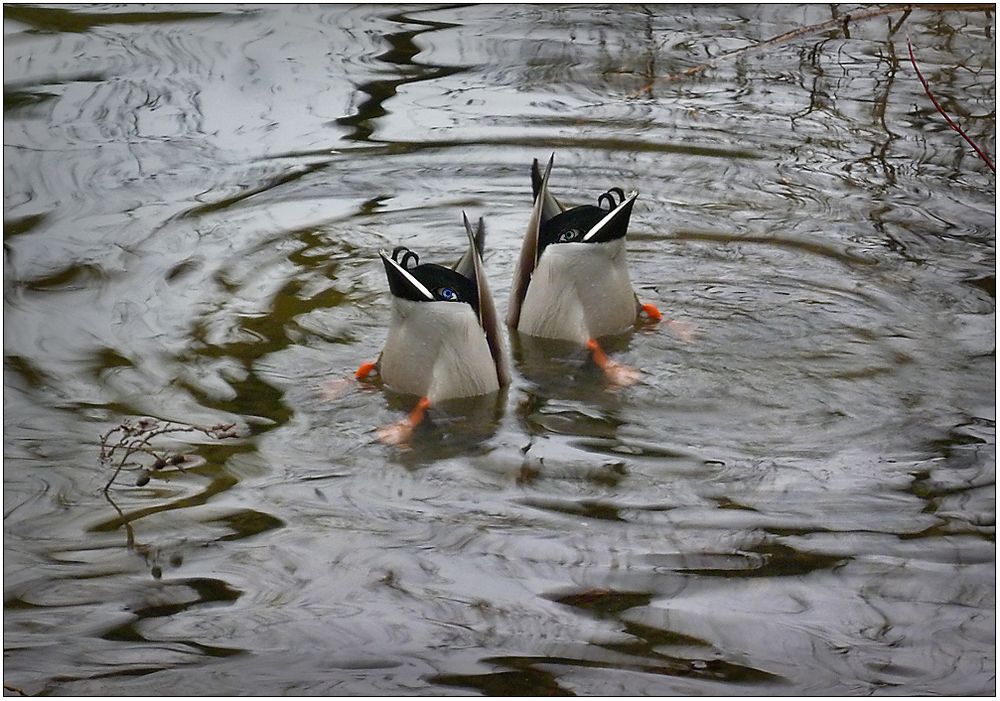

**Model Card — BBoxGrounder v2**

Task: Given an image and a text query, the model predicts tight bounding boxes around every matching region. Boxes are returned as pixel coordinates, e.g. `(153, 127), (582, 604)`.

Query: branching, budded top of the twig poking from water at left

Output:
(101, 418), (237, 495)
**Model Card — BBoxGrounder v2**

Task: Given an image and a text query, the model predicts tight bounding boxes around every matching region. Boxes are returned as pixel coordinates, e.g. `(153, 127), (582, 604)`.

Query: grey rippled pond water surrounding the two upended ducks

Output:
(4, 5), (996, 695)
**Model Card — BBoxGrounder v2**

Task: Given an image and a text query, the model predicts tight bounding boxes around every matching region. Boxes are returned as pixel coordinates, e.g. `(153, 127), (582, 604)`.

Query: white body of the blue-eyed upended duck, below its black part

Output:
(379, 297), (500, 403)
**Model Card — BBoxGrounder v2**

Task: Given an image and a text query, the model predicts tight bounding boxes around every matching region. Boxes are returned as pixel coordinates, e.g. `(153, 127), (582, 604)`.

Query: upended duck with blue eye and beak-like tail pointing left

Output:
(355, 212), (510, 444)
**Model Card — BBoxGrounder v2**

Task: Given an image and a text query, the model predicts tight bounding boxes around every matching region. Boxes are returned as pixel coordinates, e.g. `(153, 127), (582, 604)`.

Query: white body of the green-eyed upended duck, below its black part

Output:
(517, 238), (637, 344)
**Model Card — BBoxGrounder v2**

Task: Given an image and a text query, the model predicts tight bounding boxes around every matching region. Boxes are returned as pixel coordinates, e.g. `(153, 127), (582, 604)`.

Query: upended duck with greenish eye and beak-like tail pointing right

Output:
(506, 154), (662, 385)
